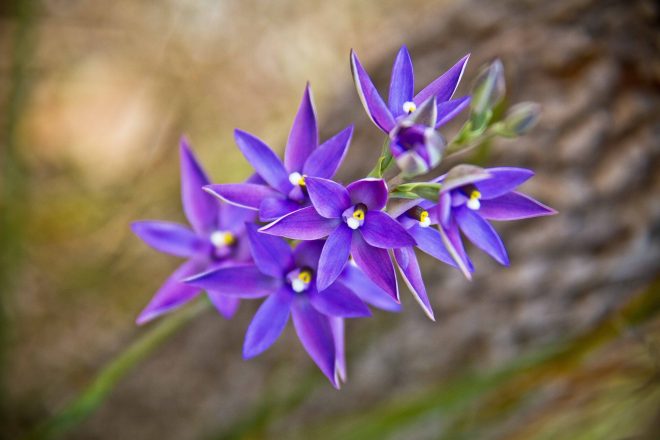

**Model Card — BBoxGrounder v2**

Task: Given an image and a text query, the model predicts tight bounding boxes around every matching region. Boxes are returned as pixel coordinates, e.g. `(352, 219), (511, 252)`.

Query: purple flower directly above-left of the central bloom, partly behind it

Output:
(204, 85), (353, 221)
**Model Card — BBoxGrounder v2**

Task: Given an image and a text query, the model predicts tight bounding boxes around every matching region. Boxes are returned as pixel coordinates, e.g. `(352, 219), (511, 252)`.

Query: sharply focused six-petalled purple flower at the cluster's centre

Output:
(260, 177), (415, 301)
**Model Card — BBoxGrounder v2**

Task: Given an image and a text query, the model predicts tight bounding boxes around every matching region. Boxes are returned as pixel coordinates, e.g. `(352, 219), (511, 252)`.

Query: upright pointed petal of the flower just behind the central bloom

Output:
(284, 84), (319, 172)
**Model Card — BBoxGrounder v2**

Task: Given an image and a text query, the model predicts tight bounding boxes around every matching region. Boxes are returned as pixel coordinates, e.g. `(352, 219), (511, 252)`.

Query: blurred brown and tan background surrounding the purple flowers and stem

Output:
(0, 0), (660, 439)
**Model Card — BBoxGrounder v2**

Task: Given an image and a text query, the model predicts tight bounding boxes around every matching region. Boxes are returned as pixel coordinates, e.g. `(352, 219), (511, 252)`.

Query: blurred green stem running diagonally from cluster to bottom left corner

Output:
(25, 300), (210, 439)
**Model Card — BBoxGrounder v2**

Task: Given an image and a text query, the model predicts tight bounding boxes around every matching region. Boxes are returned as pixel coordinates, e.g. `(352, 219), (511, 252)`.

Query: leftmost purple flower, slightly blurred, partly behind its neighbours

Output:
(131, 139), (255, 324)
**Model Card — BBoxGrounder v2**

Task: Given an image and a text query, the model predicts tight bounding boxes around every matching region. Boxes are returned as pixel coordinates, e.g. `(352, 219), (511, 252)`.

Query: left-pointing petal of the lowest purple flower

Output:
(184, 265), (282, 298)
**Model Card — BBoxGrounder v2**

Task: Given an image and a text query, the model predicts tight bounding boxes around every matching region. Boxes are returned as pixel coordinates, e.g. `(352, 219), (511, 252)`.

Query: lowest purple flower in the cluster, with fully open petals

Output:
(186, 224), (370, 387)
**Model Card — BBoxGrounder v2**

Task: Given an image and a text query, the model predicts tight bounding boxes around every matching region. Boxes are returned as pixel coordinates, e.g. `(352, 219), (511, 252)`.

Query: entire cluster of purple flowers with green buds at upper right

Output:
(132, 47), (555, 388)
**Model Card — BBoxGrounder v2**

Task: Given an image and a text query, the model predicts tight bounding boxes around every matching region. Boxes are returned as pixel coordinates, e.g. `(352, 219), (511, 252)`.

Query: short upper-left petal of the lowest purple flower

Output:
(246, 223), (293, 278)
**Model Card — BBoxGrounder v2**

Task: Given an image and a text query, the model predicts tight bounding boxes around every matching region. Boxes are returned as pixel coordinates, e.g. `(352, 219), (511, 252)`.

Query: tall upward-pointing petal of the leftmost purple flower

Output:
(179, 138), (218, 234)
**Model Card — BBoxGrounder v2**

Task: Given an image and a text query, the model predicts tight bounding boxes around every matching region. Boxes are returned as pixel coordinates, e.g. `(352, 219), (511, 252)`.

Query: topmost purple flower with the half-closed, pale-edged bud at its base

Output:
(351, 46), (470, 175)
